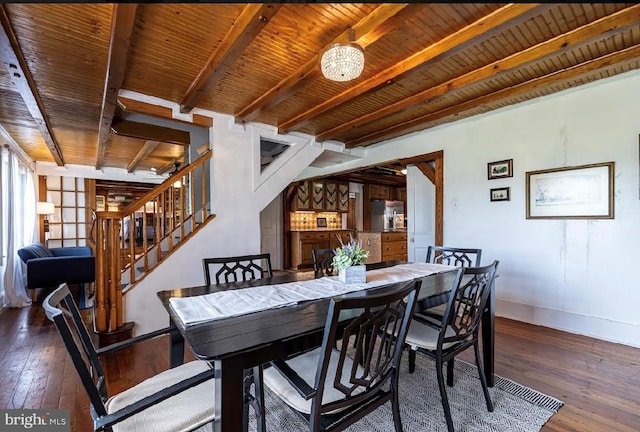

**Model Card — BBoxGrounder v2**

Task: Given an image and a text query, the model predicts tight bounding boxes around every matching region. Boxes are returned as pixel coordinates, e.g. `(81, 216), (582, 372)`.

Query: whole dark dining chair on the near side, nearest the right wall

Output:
(406, 261), (498, 432)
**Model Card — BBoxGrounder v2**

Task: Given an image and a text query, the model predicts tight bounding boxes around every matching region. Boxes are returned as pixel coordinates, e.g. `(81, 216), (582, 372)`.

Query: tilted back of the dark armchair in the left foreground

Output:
(42, 284), (107, 418)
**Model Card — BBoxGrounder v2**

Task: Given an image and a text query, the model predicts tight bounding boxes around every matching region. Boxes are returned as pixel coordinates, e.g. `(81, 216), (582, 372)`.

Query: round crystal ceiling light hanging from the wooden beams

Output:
(320, 43), (364, 81)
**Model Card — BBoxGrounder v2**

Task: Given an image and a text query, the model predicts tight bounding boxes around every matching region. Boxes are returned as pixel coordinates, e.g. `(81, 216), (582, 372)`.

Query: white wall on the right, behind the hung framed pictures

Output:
(298, 71), (640, 346)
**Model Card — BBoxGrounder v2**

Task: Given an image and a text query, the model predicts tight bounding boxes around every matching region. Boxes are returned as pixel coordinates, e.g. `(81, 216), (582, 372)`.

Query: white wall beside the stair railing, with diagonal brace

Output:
(124, 114), (323, 334)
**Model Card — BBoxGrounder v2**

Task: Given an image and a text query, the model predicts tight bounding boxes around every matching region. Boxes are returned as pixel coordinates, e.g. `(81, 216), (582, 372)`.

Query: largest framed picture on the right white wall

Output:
(526, 162), (615, 219)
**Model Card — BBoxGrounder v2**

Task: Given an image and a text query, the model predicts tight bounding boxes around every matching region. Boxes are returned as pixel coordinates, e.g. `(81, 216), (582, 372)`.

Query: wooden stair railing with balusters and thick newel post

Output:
(92, 150), (215, 332)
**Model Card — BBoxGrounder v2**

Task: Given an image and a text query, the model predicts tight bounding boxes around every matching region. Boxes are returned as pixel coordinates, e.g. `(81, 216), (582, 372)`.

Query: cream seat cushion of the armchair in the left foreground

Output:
(105, 360), (214, 432)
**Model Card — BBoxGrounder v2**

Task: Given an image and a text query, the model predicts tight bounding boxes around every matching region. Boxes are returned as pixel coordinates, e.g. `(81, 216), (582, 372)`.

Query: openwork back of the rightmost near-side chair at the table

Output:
(440, 261), (498, 343)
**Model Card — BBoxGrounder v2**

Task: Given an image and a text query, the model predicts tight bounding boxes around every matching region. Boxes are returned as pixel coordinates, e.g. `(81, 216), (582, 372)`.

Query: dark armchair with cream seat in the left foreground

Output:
(42, 284), (221, 432)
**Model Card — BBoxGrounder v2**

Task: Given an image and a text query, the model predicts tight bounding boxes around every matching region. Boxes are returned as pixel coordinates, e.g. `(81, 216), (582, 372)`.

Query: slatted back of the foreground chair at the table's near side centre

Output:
(312, 281), (421, 416)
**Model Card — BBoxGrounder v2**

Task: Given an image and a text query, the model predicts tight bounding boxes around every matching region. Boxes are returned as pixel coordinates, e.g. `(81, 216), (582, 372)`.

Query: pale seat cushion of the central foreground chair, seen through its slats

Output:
(264, 348), (364, 414)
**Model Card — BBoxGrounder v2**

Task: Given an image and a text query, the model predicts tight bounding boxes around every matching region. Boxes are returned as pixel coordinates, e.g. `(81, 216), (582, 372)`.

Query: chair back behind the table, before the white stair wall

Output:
(202, 253), (273, 285)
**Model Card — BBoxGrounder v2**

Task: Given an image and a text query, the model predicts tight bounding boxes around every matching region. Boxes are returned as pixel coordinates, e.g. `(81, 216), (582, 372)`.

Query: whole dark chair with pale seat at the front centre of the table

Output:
(264, 281), (421, 432)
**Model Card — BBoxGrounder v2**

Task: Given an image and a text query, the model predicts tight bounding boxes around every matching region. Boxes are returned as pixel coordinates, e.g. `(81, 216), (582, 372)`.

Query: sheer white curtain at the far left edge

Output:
(0, 147), (38, 307)
